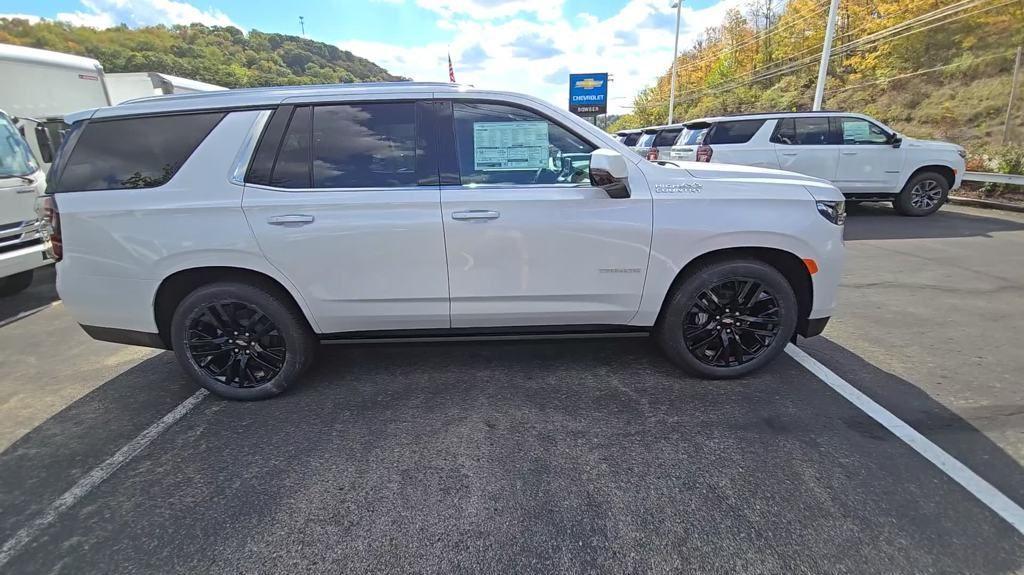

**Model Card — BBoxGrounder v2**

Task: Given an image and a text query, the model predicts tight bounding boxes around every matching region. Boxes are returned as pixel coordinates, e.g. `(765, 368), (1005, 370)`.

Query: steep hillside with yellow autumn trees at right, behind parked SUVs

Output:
(611, 0), (1024, 154)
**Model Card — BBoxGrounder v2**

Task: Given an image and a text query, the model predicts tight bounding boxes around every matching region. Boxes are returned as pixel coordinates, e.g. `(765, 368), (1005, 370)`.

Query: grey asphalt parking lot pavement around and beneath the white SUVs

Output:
(0, 206), (1024, 573)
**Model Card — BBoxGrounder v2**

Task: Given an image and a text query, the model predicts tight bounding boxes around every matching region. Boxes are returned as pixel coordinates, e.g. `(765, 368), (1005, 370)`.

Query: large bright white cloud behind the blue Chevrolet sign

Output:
(338, 0), (744, 114)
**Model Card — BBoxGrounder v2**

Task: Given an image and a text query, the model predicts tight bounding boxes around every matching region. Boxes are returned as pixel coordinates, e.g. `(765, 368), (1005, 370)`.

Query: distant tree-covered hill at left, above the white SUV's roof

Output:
(0, 18), (406, 88)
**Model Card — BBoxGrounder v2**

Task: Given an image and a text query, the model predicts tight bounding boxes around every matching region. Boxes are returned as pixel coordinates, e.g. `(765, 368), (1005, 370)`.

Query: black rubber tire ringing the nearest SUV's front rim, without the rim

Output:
(656, 261), (799, 380)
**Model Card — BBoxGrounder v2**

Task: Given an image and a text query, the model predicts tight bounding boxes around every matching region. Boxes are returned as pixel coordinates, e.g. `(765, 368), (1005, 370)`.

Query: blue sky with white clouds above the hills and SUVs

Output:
(0, 0), (744, 114)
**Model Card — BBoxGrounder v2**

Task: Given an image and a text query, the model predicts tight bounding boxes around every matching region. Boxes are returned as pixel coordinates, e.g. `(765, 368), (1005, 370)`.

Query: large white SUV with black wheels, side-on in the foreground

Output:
(43, 83), (845, 399)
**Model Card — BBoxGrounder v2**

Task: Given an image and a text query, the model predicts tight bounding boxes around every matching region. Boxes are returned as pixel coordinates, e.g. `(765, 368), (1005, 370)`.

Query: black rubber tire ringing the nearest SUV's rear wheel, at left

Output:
(171, 283), (314, 400)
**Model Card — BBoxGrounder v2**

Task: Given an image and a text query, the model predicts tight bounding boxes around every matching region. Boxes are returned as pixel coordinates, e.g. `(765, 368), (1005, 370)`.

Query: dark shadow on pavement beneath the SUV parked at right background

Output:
(844, 204), (1024, 241)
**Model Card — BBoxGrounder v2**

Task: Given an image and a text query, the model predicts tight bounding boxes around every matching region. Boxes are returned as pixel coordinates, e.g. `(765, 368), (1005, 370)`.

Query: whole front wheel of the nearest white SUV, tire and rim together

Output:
(654, 260), (799, 380)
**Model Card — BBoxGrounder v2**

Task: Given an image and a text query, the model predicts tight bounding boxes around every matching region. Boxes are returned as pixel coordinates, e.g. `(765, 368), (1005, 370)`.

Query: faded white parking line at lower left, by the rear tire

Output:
(0, 390), (210, 568)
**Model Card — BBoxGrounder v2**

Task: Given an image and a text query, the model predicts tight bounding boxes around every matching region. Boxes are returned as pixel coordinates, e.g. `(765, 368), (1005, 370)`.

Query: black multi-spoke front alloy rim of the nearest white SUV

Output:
(683, 277), (782, 367)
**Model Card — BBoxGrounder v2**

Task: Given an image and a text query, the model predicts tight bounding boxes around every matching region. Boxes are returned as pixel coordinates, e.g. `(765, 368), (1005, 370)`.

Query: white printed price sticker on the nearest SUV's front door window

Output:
(473, 121), (549, 172)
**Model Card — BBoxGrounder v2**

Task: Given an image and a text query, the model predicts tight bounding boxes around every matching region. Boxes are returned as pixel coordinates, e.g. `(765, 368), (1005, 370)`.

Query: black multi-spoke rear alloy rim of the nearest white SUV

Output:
(185, 301), (288, 388)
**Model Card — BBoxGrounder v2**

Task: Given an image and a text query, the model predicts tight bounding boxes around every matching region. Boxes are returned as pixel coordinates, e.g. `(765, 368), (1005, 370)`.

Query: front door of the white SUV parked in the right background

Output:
(833, 117), (903, 193)
